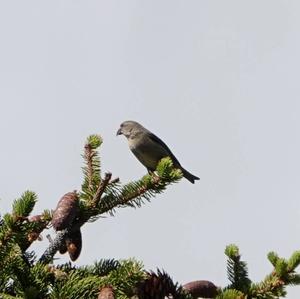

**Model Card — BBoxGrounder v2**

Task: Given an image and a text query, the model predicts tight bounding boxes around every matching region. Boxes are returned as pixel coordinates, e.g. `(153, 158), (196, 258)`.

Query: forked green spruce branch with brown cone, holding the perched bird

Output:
(40, 135), (182, 263)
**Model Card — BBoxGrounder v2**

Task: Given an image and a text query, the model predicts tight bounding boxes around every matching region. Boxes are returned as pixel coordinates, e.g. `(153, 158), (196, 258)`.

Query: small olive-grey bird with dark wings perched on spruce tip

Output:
(117, 120), (199, 184)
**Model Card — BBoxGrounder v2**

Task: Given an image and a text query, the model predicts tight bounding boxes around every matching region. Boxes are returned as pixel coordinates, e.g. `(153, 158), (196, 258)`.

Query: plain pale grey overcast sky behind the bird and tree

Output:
(0, 0), (300, 299)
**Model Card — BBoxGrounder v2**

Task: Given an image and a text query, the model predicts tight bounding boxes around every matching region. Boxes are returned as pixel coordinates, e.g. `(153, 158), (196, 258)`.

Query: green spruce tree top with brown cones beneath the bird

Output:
(0, 135), (300, 299)
